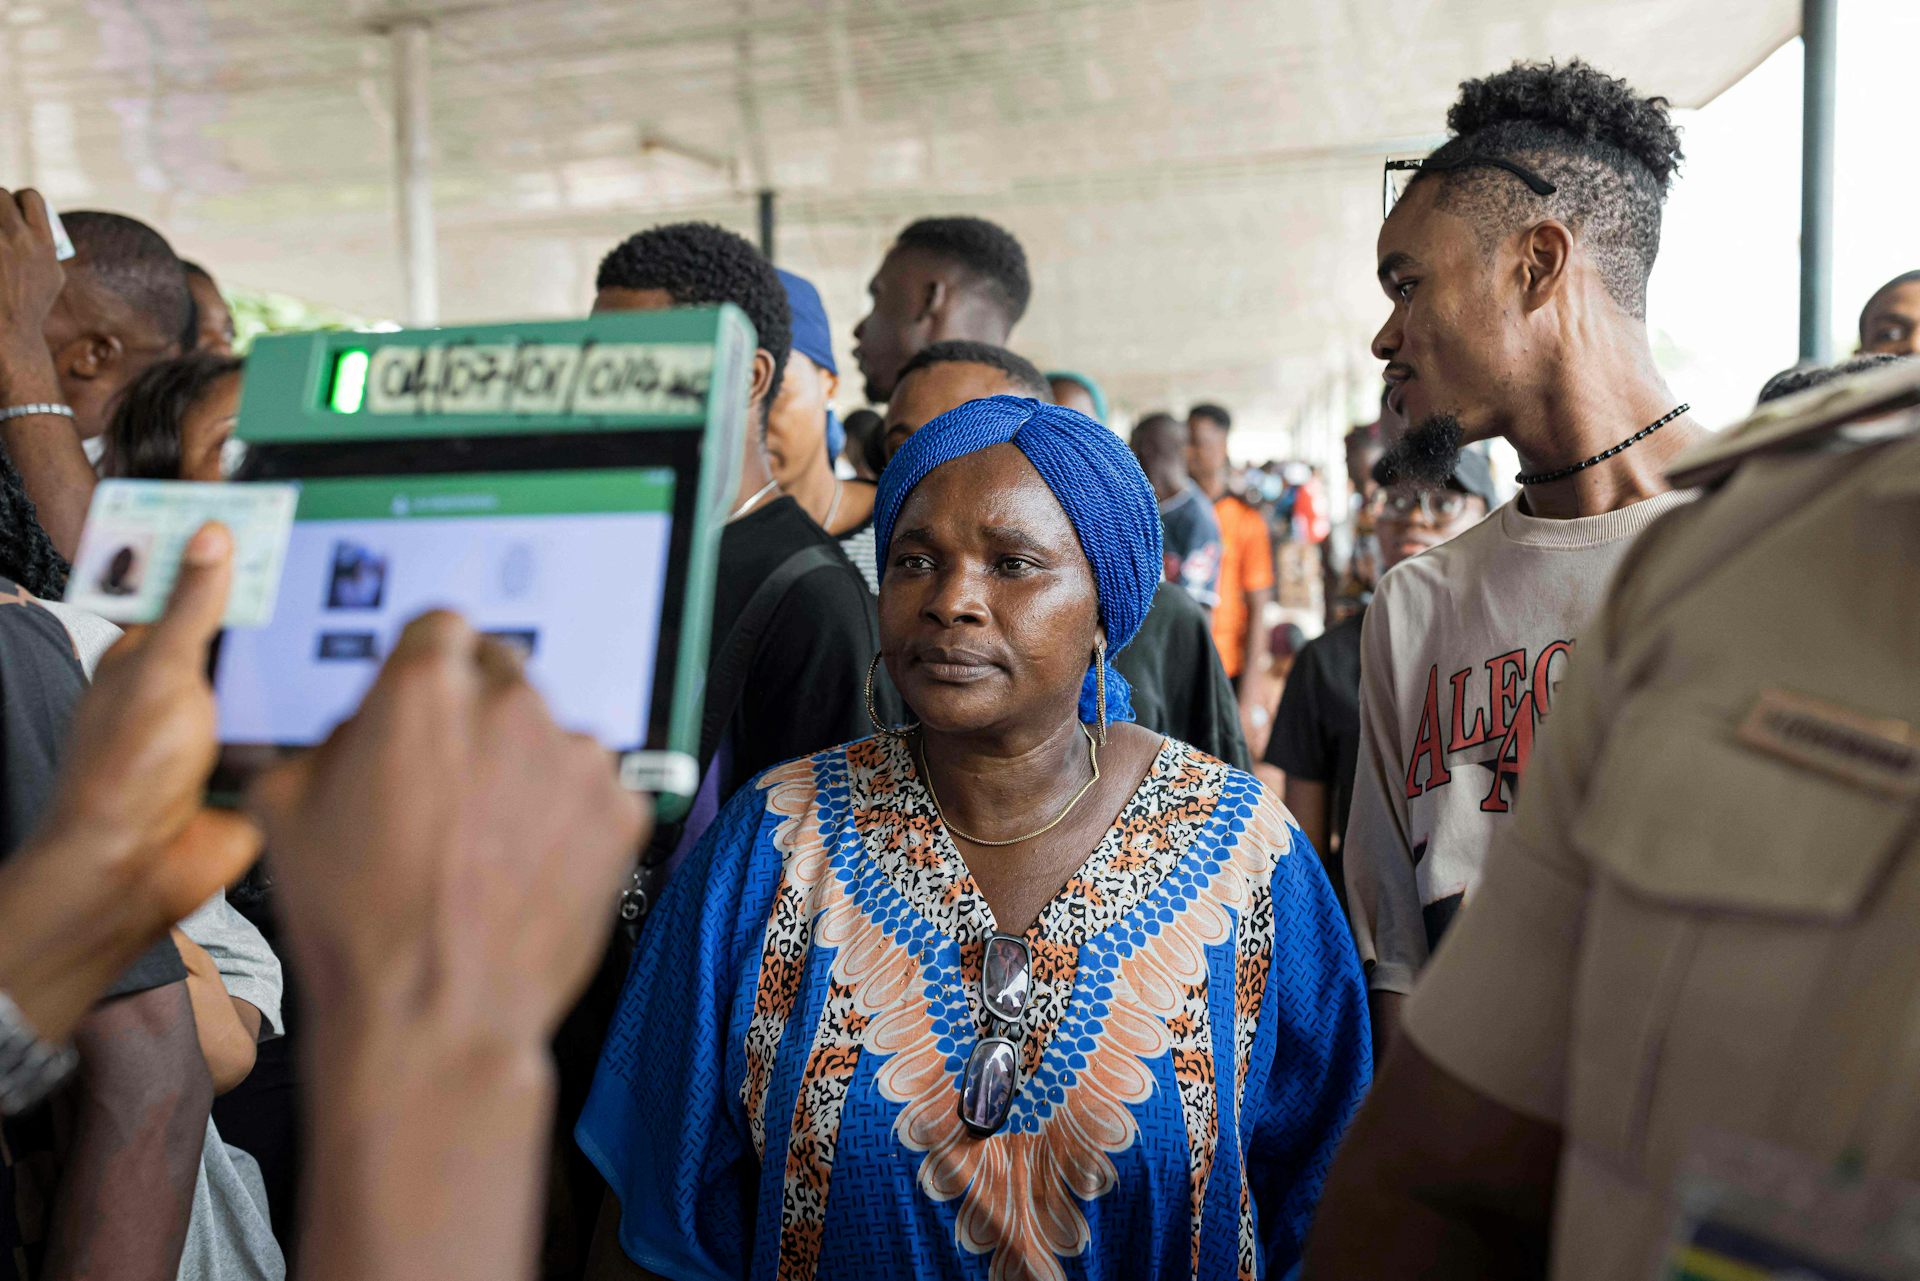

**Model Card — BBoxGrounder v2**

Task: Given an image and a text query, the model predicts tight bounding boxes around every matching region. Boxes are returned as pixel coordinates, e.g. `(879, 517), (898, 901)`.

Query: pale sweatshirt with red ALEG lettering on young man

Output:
(1344, 492), (1693, 993)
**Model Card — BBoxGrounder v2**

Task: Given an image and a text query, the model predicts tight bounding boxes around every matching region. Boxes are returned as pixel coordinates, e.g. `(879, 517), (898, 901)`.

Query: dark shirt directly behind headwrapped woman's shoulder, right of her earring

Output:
(1114, 582), (1248, 770)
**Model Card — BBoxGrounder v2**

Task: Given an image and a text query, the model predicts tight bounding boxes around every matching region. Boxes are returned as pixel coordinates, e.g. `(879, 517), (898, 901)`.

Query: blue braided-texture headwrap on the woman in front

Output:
(874, 396), (1165, 722)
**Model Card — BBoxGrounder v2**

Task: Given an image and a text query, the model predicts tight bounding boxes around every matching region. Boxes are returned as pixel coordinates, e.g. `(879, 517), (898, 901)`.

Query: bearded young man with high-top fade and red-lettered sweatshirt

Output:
(1346, 61), (1699, 1037)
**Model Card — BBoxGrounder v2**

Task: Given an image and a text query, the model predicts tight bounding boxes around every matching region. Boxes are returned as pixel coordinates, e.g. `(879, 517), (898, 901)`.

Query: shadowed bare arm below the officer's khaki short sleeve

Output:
(1302, 1037), (1561, 1281)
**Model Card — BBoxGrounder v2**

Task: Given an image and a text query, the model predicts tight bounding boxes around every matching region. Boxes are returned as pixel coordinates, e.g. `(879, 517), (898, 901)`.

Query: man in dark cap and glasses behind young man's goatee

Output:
(1265, 449), (1500, 897)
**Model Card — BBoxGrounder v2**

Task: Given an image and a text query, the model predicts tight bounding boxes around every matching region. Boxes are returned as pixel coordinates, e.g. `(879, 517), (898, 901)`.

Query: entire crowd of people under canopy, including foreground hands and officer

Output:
(0, 47), (1920, 1281)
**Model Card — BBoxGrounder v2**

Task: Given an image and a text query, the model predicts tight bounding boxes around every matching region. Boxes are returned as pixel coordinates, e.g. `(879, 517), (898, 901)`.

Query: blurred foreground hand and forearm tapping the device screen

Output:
(253, 615), (647, 1281)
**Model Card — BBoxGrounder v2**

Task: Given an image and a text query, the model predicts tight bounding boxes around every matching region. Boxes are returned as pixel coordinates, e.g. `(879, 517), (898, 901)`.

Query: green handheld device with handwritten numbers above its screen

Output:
(213, 305), (755, 818)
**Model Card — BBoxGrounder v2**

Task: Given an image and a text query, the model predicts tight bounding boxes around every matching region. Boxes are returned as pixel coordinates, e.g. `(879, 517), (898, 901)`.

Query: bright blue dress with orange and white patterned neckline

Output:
(576, 739), (1371, 1281)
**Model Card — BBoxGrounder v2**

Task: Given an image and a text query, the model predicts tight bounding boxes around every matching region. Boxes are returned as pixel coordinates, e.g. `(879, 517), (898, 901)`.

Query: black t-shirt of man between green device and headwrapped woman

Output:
(701, 495), (900, 795)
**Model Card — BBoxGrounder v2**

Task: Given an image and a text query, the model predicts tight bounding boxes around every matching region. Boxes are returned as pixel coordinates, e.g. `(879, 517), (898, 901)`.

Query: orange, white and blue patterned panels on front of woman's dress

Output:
(741, 739), (1290, 1281)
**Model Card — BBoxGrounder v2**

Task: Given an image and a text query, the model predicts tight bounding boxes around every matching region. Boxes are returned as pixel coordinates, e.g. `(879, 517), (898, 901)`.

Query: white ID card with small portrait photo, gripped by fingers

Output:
(67, 480), (300, 628)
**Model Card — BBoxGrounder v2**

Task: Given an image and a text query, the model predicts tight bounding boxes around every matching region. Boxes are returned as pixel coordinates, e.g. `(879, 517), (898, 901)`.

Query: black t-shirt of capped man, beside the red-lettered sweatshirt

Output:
(1267, 611), (1367, 860)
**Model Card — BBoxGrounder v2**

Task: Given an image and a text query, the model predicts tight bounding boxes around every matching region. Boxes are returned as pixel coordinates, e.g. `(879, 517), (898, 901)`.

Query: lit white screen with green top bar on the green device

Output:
(215, 471), (672, 751)
